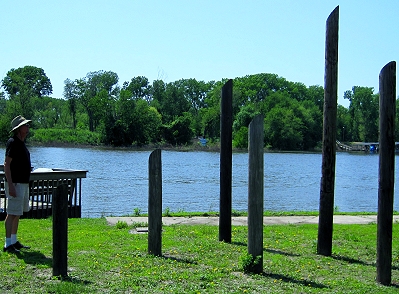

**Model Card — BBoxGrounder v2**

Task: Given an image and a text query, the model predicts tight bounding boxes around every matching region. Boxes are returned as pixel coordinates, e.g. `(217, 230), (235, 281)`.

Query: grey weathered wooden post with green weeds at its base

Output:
(248, 114), (264, 273)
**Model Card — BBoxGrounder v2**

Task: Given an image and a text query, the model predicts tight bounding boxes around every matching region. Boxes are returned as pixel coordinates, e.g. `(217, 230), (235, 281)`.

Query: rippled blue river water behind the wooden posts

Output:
(0, 147), (399, 217)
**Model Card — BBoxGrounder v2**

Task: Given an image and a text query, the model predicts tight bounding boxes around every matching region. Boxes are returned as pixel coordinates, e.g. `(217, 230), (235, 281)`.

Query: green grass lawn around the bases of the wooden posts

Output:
(0, 218), (399, 293)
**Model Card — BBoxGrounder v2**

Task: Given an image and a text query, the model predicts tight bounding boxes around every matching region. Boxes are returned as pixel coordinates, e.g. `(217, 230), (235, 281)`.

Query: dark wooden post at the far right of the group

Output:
(377, 61), (396, 285)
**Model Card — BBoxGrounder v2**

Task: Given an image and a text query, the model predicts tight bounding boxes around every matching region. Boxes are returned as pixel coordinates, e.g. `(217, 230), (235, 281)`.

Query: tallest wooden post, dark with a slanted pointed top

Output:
(317, 6), (339, 256)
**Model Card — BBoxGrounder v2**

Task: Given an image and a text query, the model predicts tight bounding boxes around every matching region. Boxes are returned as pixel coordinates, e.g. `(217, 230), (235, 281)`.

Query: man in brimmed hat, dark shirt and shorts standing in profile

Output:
(3, 115), (31, 253)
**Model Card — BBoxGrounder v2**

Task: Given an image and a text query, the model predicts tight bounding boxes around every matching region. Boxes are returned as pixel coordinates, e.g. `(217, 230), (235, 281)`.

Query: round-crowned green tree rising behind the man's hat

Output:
(1, 65), (53, 117)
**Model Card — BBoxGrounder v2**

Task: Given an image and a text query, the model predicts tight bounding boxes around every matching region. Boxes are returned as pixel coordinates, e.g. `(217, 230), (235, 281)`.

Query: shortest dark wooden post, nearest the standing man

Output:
(52, 184), (68, 277)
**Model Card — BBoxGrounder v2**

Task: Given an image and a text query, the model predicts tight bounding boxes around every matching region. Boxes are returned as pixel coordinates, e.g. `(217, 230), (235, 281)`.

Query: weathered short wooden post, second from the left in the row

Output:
(148, 149), (162, 256)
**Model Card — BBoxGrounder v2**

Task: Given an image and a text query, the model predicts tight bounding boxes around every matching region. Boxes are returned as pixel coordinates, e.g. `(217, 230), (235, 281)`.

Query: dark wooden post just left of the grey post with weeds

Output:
(219, 80), (233, 243)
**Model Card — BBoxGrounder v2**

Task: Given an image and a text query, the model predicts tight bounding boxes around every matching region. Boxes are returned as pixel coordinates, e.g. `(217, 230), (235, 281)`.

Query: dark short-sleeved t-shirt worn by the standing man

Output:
(6, 136), (31, 183)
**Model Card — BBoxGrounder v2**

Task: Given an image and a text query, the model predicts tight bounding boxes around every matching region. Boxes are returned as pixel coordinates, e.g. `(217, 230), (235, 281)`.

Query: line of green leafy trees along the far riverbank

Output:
(0, 66), (399, 150)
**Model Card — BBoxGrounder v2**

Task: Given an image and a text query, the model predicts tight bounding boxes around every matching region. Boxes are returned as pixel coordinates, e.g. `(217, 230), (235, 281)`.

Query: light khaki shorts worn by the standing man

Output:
(5, 182), (29, 215)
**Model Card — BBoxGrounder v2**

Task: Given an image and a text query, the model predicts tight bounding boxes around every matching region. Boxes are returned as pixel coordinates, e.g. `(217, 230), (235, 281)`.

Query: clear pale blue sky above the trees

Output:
(0, 0), (399, 106)
